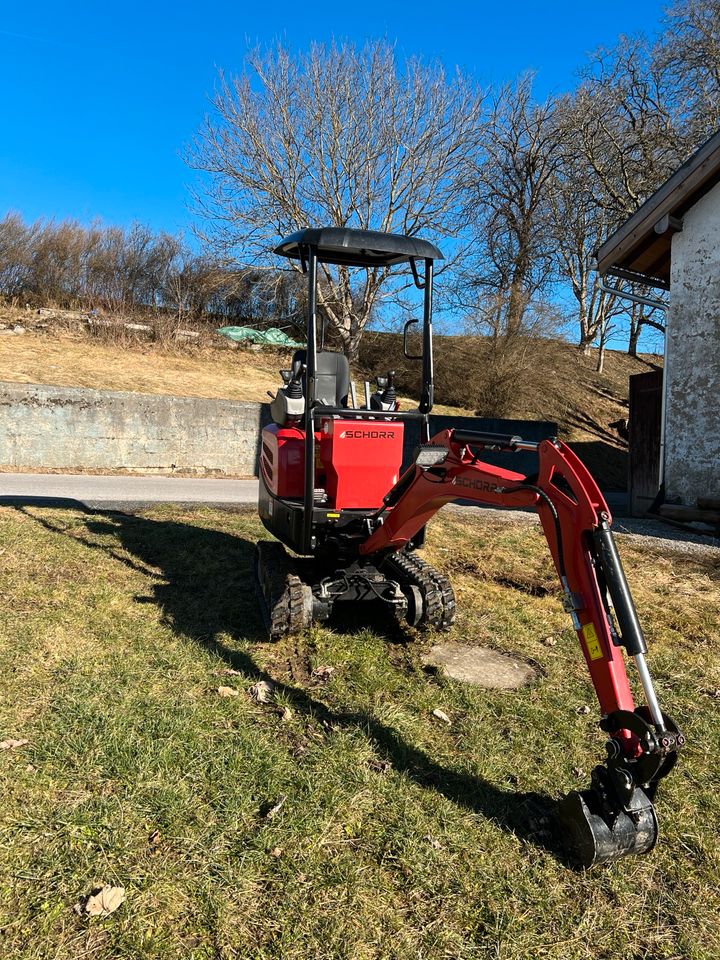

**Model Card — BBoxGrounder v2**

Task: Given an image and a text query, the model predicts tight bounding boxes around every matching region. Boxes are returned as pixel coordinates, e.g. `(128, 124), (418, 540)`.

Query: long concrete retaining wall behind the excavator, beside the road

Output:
(0, 383), (557, 476)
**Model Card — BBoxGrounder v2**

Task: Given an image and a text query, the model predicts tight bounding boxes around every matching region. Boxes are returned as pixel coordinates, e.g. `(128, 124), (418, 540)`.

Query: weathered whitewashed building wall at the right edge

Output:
(665, 184), (720, 505)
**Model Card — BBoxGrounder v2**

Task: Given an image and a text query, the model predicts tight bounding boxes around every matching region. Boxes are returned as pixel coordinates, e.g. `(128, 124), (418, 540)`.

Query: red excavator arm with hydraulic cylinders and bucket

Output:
(360, 430), (684, 867)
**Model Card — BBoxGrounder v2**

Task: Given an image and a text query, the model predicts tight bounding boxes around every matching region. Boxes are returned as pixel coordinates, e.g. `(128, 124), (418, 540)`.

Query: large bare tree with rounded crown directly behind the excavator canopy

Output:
(189, 41), (482, 360)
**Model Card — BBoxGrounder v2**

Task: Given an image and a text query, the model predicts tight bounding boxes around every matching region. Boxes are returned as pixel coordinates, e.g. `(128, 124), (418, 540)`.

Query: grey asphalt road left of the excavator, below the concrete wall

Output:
(0, 473), (258, 510)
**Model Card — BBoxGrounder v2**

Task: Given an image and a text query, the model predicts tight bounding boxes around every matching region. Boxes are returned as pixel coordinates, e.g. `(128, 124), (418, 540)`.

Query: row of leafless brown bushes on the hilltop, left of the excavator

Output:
(0, 213), (306, 336)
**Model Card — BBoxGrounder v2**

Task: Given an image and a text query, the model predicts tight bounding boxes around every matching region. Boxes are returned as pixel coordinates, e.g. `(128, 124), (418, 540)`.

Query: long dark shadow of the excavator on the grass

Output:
(5, 498), (573, 867)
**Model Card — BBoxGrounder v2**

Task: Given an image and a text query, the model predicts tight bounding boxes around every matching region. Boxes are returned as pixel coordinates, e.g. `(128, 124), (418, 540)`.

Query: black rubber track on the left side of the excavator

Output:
(255, 540), (310, 640)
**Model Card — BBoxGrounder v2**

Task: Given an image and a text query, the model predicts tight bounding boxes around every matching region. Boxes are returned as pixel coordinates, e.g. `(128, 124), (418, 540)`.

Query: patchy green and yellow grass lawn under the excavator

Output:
(0, 507), (720, 960)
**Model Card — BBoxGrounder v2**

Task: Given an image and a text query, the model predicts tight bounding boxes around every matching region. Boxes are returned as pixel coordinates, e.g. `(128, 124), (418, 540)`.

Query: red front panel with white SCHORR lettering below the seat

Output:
(320, 418), (404, 510)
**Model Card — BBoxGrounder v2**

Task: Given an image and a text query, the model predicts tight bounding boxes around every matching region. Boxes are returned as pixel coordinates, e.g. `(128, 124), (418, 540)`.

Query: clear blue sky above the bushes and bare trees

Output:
(0, 0), (664, 238)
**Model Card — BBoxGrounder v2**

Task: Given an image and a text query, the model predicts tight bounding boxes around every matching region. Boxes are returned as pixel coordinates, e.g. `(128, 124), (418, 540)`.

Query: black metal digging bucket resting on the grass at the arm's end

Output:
(558, 787), (658, 870)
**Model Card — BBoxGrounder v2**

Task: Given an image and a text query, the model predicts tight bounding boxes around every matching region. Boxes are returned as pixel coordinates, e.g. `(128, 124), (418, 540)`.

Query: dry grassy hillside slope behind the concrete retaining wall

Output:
(0, 309), (662, 489)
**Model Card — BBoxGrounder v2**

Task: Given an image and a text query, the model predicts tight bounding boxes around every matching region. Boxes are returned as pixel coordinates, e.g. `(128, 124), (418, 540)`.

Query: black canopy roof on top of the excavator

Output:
(274, 227), (443, 267)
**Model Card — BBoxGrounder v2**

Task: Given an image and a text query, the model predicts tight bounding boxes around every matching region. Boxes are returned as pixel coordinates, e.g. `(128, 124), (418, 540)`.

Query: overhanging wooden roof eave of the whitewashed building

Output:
(597, 130), (720, 290)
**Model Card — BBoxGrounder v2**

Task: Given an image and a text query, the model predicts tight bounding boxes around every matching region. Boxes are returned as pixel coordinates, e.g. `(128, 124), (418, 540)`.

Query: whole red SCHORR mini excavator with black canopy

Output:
(256, 227), (684, 867)
